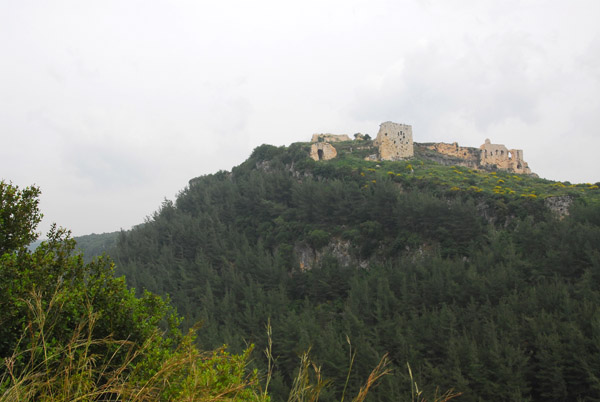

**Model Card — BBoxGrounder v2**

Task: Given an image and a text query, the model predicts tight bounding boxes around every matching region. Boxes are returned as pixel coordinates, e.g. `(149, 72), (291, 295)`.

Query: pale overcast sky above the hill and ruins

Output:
(0, 0), (600, 235)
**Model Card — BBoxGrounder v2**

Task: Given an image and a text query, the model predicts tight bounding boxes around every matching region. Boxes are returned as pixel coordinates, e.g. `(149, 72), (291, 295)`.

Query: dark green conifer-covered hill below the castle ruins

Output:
(111, 143), (600, 401)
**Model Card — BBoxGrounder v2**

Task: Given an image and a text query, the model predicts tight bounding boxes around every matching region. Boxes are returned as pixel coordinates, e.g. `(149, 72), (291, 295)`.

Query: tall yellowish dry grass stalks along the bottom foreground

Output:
(0, 292), (459, 402)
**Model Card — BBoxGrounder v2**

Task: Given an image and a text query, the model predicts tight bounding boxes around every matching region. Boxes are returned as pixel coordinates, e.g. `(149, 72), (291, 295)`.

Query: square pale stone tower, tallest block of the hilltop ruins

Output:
(373, 121), (414, 161)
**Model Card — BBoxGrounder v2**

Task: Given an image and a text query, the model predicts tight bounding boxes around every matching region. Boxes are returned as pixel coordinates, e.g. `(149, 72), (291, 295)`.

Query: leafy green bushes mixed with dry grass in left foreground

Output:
(0, 182), (269, 402)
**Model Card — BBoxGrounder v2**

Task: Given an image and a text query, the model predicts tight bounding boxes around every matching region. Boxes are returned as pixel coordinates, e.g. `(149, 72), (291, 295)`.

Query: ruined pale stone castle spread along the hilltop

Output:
(310, 121), (532, 174)
